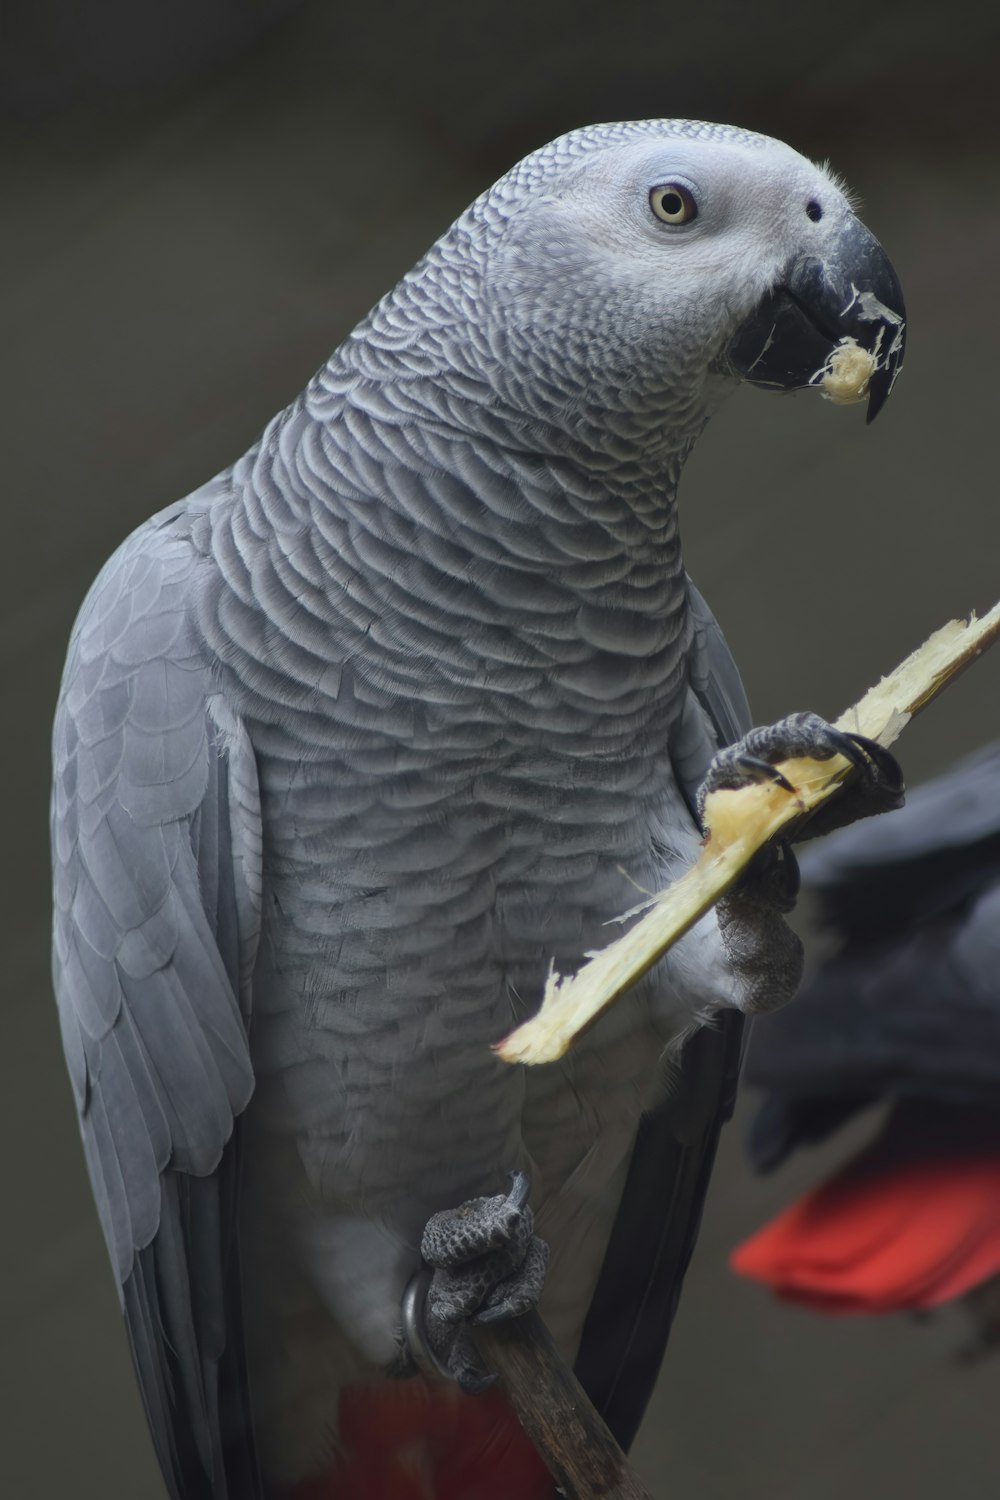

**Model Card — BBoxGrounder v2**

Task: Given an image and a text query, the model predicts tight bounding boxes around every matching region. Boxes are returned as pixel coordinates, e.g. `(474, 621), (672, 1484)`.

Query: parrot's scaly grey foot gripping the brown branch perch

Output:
(403, 1172), (549, 1395)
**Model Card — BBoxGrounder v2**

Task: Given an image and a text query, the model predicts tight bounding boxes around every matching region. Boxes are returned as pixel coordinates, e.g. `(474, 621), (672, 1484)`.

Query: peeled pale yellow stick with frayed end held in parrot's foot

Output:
(496, 605), (1000, 1064)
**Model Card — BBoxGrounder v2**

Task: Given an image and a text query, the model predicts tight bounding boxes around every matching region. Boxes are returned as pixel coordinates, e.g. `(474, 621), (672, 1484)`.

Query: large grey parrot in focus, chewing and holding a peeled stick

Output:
(52, 120), (904, 1500)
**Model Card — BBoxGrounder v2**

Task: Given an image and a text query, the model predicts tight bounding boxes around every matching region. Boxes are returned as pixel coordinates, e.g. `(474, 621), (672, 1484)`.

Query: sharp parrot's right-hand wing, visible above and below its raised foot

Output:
(576, 581), (750, 1448)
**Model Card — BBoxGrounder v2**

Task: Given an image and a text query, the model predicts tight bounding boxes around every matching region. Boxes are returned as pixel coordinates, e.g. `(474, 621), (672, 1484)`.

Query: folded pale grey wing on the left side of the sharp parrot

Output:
(52, 507), (261, 1500)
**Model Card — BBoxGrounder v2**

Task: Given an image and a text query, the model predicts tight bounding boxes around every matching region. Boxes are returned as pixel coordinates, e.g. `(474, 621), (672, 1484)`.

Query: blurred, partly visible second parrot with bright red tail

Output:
(733, 744), (1000, 1353)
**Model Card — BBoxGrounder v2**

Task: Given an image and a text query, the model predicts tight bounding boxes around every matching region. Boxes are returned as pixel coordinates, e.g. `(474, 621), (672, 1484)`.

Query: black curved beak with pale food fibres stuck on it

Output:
(729, 216), (906, 422)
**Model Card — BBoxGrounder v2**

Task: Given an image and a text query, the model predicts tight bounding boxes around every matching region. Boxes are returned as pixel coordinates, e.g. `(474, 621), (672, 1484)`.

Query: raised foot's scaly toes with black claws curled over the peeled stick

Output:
(697, 713), (903, 840)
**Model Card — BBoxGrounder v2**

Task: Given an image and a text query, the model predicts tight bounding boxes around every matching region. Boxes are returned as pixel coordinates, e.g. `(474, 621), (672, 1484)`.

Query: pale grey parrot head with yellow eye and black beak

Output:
(453, 120), (906, 431)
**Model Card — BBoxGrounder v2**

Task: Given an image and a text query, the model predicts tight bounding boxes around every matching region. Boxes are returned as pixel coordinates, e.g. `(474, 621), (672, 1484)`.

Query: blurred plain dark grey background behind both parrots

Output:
(0, 0), (1000, 1500)
